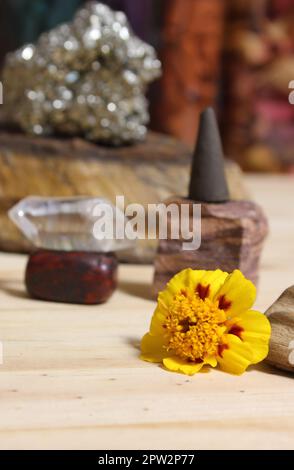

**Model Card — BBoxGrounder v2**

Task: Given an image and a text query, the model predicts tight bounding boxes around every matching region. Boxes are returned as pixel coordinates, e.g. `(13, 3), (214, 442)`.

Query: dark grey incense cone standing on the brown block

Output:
(188, 108), (230, 203)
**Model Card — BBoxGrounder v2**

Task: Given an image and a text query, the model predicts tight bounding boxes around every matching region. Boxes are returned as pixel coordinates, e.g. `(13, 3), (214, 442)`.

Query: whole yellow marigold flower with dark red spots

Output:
(141, 269), (271, 375)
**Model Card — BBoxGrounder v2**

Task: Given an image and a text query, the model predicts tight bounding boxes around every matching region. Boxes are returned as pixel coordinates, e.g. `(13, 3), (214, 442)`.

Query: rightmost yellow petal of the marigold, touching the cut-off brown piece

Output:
(232, 310), (271, 364)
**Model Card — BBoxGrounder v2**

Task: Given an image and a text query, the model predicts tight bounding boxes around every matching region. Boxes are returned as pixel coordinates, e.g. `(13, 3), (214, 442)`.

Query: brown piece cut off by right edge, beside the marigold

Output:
(266, 286), (294, 373)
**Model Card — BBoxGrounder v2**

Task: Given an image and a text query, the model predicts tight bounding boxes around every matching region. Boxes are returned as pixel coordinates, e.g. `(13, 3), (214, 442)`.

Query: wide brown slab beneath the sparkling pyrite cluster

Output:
(0, 132), (246, 263)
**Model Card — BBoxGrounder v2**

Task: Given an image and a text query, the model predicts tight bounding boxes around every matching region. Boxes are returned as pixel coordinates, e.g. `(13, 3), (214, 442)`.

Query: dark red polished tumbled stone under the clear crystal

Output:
(25, 250), (118, 305)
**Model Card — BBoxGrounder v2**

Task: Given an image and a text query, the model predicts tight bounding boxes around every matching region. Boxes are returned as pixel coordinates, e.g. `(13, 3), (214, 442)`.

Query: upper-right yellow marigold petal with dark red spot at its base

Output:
(215, 269), (256, 317)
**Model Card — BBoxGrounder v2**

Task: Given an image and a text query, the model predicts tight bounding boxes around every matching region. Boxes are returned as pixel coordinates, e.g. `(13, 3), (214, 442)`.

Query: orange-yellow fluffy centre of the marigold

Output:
(164, 292), (227, 362)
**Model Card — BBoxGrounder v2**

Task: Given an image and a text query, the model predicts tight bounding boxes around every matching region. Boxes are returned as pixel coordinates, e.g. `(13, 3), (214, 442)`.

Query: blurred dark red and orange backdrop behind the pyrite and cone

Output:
(0, 0), (294, 172)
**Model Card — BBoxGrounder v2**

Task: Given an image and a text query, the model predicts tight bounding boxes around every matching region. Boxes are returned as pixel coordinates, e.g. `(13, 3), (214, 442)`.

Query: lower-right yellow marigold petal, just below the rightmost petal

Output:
(217, 335), (253, 375)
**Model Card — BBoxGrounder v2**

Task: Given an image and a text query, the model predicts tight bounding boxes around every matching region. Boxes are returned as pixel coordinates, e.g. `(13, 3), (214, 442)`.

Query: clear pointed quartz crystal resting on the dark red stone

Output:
(8, 196), (134, 253)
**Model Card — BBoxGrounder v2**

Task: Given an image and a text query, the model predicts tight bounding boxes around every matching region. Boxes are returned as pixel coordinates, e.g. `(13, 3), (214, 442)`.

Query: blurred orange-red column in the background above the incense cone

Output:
(153, 0), (225, 144)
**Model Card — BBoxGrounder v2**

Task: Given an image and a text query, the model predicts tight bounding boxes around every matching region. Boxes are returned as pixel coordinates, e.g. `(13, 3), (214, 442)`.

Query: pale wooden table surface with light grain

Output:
(0, 176), (294, 449)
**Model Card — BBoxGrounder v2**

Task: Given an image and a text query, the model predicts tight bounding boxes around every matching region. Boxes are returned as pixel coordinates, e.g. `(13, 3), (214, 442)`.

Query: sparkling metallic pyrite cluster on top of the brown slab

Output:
(3, 3), (161, 145)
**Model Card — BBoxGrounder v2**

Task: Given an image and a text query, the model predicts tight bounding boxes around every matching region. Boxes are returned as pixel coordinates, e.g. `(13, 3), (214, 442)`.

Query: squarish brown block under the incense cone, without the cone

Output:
(153, 199), (268, 296)
